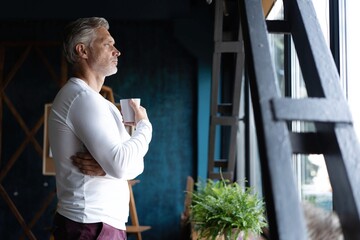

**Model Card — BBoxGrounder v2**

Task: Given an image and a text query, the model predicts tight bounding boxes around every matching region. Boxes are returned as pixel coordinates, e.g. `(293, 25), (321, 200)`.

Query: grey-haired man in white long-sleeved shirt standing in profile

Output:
(49, 17), (152, 240)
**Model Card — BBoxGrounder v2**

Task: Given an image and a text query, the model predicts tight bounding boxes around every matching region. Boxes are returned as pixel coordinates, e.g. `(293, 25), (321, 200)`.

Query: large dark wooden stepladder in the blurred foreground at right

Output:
(239, 0), (360, 240)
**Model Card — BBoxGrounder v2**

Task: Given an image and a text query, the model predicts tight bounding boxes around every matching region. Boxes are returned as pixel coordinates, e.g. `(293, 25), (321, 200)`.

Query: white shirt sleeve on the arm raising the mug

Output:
(68, 92), (152, 179)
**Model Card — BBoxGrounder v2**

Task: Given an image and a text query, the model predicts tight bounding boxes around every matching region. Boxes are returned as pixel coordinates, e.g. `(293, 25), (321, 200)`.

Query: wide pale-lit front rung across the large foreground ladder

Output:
(271, 98), (352, 123)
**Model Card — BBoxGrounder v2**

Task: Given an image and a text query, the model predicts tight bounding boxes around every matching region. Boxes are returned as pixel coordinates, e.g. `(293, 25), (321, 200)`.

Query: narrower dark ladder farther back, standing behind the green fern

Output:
(208, 0), (244, 181)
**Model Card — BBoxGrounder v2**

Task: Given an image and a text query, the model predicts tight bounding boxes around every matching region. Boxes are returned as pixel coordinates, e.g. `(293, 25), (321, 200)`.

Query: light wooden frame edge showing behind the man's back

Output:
(43, 103), (55, 176)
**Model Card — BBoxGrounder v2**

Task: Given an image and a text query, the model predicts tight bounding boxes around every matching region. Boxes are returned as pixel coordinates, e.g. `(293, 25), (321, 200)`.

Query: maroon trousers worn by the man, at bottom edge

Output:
(53, 213), (126, 240)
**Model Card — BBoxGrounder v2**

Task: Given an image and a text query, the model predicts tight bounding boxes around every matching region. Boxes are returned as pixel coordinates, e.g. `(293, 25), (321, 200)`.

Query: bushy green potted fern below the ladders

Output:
(190, 176), (267, 240)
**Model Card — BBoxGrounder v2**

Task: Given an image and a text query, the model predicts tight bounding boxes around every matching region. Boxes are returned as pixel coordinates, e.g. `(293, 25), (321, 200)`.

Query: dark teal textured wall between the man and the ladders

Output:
(106, 21), (198, 239)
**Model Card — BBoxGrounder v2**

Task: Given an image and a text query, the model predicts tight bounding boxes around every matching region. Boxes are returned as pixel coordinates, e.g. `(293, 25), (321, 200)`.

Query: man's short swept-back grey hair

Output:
(63, 17), (109, 64)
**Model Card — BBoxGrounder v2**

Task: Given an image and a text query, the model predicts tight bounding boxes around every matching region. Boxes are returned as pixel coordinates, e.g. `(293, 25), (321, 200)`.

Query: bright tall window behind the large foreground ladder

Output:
(238, 0), (360, 214)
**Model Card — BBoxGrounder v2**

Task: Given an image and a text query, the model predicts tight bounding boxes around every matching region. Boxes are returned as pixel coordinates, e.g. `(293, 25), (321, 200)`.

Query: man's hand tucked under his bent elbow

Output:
(71, 152), (106, 176)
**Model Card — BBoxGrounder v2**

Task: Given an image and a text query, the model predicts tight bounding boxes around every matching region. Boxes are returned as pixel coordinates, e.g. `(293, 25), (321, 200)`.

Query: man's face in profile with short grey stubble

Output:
(88, 27), (120, 77)
